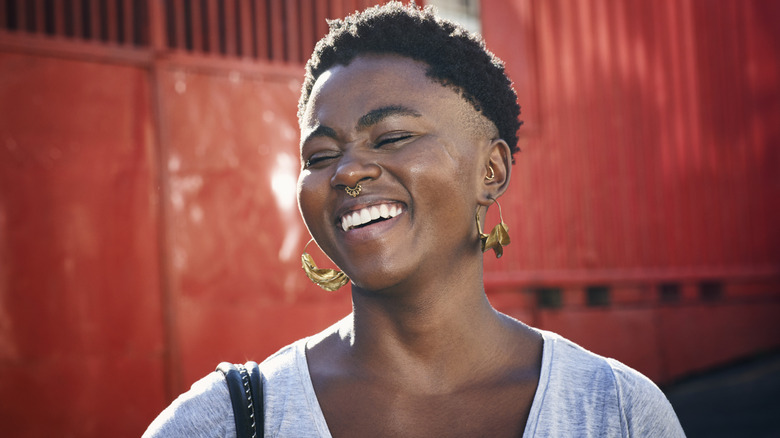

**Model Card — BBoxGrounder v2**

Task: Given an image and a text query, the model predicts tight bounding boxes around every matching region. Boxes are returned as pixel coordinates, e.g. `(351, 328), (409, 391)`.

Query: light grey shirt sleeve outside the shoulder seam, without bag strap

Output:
(608, 359), (685, 438)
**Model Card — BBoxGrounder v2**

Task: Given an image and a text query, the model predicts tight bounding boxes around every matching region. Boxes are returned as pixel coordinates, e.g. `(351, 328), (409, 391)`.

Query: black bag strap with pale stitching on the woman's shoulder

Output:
(217, 361), (264, 438)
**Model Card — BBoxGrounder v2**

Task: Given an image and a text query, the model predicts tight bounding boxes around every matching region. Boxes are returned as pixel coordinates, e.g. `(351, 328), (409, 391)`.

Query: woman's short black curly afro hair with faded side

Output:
(298, 2), (522, 162)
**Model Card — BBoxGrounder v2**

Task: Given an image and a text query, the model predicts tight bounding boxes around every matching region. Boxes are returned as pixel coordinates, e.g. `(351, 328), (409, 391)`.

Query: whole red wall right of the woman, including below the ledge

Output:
(482, 0), (780, 381)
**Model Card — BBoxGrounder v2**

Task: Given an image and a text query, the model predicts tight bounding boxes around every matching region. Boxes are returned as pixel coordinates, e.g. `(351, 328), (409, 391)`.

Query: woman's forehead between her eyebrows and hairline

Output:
(301, 55), (478, 129)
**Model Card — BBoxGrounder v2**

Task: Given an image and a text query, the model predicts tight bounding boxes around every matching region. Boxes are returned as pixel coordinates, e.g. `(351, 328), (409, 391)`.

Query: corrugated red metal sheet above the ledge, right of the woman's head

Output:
(483, 0), (780, 278)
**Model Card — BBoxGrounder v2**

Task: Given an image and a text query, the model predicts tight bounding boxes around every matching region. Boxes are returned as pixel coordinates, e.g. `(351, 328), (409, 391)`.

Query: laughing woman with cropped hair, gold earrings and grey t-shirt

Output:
(147, 3), (683, 437)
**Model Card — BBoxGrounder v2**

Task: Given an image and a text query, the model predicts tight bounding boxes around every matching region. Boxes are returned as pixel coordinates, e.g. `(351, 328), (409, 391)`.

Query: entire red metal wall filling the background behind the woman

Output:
(0, 0), (780, 437)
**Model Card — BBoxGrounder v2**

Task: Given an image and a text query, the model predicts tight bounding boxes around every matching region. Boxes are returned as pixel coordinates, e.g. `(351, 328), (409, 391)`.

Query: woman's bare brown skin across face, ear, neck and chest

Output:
(298, 55), (542, 437)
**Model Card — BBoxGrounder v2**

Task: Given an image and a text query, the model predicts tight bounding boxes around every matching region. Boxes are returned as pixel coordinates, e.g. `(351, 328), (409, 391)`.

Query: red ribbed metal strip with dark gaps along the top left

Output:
(0, 0), (377, 64)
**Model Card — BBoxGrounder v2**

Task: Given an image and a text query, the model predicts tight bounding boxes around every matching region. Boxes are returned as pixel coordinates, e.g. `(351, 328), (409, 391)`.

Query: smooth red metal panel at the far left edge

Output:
(0, 51), (166, 437)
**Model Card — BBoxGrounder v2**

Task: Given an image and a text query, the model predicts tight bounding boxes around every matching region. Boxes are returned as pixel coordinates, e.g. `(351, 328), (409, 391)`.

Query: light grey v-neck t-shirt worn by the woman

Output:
(143, 331), (685, 438)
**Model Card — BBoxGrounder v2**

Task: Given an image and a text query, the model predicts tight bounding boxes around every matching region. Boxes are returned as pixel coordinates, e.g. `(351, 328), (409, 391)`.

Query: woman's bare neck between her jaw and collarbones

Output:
(342, 263), (506, 385)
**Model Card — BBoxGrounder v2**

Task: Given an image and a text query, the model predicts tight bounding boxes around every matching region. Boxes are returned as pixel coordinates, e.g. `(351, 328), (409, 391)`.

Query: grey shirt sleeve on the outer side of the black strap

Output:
(142, 372), (236, 438)
